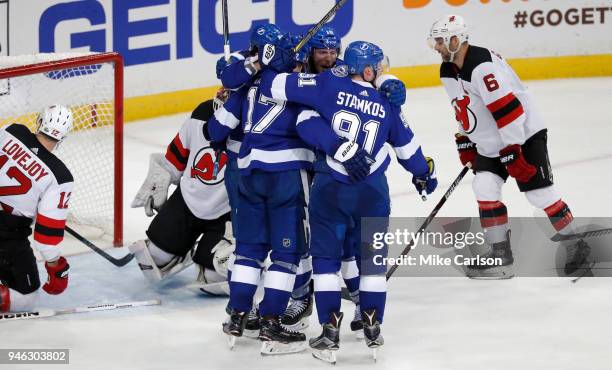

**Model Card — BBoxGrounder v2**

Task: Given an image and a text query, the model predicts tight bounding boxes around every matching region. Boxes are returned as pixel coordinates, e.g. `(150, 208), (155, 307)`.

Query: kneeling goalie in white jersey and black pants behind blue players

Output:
(129, 100), (234, 295)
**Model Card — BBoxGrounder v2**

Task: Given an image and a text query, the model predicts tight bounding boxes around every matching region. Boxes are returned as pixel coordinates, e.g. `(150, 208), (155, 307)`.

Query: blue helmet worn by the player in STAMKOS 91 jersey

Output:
(344, 41), (389, 75)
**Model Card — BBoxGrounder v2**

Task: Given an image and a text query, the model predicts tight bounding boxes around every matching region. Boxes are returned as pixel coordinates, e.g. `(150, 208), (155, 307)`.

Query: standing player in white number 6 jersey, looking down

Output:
(428, 15), (590, 278)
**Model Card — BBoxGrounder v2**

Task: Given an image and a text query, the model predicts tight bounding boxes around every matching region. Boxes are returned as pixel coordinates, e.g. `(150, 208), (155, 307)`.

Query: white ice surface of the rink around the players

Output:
(0, 78), (612, 370)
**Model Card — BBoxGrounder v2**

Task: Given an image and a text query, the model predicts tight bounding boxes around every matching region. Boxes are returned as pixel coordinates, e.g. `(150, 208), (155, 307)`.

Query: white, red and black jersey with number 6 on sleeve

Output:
(440, 45), (545, 158)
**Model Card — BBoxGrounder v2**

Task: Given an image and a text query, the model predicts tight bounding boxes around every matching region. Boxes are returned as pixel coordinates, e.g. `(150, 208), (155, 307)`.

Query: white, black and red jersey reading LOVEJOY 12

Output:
(0, 124), (73, 261)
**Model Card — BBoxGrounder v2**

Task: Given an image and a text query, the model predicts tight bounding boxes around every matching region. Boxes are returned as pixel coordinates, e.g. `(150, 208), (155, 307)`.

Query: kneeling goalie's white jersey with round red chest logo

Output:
(166, 100), (230, 220)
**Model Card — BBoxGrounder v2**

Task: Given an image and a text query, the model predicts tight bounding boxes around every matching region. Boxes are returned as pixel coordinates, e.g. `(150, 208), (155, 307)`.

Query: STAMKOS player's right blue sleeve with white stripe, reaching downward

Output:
(387, 108), (429, 176)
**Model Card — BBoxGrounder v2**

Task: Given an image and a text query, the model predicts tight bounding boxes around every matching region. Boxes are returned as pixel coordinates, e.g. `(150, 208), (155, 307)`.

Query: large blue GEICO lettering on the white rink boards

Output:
(38, 0), (354, 66)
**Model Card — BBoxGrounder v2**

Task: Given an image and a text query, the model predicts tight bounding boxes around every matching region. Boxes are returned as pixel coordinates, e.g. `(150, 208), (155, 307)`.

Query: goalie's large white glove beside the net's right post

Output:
(131, 153), (172, 217)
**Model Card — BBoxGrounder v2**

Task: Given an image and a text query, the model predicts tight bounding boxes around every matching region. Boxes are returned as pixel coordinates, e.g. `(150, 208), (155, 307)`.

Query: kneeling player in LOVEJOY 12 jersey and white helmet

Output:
(0, 105), (73, 312)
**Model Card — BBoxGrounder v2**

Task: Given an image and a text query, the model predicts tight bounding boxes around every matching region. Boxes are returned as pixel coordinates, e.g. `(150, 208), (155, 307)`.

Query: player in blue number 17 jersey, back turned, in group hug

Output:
(207, 37), (314, 354)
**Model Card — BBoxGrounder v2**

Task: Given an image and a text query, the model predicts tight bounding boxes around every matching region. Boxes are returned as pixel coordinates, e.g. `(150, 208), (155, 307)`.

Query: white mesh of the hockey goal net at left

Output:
(0, 54), (120, 243)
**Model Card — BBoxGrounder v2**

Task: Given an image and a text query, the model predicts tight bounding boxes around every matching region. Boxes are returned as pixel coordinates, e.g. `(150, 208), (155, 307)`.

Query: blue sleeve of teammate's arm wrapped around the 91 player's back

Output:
(296, 109), (341, 157)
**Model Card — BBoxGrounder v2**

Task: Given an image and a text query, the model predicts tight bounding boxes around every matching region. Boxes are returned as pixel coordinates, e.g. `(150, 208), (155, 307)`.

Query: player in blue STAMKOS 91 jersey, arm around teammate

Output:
(260, 41), (437, 361)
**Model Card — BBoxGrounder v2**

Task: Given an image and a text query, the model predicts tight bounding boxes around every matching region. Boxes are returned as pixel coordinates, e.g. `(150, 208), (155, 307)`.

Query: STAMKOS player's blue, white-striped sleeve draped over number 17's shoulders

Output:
(259, 70), (325, 109)
